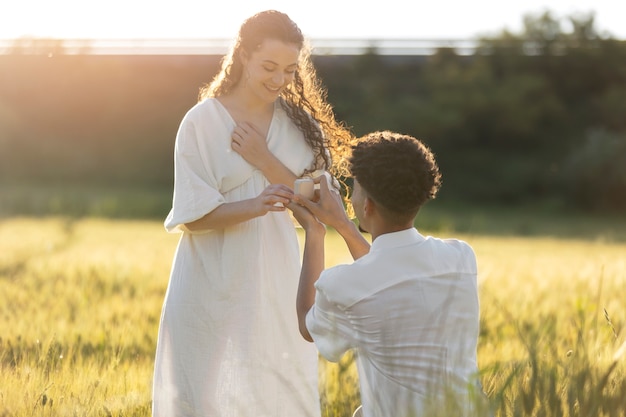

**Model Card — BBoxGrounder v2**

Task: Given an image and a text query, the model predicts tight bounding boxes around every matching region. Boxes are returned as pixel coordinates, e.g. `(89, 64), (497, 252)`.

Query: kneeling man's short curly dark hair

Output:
(348, 131), (441, 215)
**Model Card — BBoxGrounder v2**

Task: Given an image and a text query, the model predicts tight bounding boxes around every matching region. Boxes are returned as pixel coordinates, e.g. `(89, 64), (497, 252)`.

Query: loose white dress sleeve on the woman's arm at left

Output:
(165, 112), (224, 233)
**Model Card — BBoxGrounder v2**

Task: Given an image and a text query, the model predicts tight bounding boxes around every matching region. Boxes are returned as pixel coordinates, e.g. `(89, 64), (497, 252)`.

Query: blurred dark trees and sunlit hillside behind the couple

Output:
(0, 12), (626, 212)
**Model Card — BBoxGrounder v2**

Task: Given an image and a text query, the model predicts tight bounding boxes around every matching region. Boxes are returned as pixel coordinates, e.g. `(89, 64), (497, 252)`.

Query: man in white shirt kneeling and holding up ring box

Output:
(289, 131), (484, 417)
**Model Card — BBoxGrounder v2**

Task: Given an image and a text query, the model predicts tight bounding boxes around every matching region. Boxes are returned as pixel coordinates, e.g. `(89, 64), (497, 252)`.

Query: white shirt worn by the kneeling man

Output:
(306, 228), (479, 417)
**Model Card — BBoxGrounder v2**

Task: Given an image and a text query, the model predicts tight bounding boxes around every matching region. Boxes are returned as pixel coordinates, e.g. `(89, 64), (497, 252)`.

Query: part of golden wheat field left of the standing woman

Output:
(0, 219), (175, 416)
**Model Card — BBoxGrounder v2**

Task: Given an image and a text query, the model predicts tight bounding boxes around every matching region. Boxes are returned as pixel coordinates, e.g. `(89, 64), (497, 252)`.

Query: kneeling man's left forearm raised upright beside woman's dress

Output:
(288, 203), (326, 342)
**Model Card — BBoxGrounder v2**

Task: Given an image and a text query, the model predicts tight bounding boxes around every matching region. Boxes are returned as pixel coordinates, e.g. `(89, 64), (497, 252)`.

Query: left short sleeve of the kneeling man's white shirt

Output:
(306, 277), (354, 362)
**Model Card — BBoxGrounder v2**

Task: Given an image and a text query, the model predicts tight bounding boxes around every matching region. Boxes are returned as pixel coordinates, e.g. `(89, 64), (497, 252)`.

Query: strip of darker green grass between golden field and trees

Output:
(0, 183), (626, 242)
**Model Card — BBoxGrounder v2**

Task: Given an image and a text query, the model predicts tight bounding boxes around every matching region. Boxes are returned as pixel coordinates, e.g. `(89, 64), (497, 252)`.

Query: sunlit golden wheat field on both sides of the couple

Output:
(0, 218), (626, 417)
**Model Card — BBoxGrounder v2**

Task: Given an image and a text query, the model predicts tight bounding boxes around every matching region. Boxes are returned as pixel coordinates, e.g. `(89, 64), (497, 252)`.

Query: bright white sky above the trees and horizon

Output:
(0, 0), (626, 40)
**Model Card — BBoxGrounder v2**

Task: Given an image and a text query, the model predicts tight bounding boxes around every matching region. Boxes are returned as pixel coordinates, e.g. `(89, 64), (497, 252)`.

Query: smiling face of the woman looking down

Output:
(241, 39), (300, 102)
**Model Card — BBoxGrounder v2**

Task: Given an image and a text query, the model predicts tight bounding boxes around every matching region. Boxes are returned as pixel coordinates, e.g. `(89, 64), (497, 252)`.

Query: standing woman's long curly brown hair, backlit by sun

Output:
(199, 10), (354, 177)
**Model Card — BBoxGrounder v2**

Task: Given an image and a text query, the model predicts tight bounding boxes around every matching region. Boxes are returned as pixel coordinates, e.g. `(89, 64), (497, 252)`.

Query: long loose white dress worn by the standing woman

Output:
(152, 99), (320, 417)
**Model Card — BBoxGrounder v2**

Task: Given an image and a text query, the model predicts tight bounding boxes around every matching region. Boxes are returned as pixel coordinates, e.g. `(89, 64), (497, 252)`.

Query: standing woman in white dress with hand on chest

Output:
(153, 11), (352, 417)
